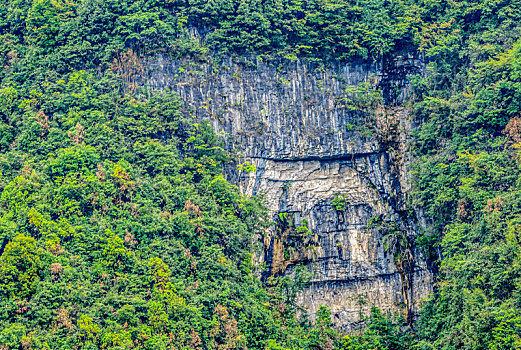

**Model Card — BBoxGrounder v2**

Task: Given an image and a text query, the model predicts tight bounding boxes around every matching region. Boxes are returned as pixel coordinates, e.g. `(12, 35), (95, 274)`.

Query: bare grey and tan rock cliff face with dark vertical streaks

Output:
(147, 56), (432, 331)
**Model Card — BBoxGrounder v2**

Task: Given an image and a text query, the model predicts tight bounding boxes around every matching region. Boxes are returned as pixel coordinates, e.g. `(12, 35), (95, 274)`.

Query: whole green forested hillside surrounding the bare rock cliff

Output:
(0, 0), (521, 350)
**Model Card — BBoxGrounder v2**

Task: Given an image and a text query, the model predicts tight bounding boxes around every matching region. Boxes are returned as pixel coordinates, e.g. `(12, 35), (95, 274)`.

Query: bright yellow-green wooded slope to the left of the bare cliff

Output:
(0, 67), (312, 349)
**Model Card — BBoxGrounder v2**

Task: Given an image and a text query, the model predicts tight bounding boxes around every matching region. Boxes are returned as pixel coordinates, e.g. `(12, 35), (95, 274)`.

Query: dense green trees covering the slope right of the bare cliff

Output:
(415, 3), (521, 349)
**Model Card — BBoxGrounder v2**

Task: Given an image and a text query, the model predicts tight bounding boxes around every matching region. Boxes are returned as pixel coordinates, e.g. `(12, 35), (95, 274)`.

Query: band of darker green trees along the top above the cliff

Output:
(4, 0), (519, 69)
